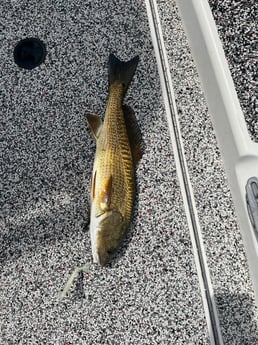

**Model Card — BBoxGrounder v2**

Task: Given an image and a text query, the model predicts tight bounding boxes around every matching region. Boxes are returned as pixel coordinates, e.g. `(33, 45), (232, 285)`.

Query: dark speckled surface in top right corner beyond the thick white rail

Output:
(209, 0), (258, 142)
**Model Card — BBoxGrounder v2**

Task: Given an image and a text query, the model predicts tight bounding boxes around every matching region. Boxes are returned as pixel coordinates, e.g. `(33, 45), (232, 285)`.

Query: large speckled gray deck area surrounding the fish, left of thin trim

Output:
(0, 0), (210, 345)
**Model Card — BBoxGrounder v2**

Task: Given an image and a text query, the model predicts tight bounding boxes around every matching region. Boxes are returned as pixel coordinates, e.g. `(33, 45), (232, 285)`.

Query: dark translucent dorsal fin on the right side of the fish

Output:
(123, 105), (144, 166)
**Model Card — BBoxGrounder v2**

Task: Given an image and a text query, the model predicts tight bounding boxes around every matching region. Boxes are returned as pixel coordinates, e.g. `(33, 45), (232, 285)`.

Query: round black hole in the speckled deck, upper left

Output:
(13, 38), (46, 69)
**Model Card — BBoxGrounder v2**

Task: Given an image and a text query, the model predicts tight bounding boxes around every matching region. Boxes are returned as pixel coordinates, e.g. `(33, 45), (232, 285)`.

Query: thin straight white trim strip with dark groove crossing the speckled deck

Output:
(145, 0), (223, 345)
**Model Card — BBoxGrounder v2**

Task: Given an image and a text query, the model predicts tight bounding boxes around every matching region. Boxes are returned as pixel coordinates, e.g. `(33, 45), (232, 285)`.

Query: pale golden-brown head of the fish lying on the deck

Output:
(91, 210), (126, 266)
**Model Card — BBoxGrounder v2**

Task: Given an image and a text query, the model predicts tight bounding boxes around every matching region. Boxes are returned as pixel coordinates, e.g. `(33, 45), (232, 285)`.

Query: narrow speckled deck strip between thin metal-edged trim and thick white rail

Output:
(158, 1), (258, 345)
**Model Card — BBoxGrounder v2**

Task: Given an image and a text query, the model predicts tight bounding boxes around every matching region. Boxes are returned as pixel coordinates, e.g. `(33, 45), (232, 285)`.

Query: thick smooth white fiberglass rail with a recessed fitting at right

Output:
(176, 0), (258, 305)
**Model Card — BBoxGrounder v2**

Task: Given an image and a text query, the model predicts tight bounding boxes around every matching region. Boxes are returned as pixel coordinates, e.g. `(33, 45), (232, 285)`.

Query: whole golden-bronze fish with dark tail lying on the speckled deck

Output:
(86, 54), (143, 266)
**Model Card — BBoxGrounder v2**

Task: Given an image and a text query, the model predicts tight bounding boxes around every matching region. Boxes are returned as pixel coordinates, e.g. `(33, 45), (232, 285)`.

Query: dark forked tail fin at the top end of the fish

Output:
(109, 54), (139, 92)
